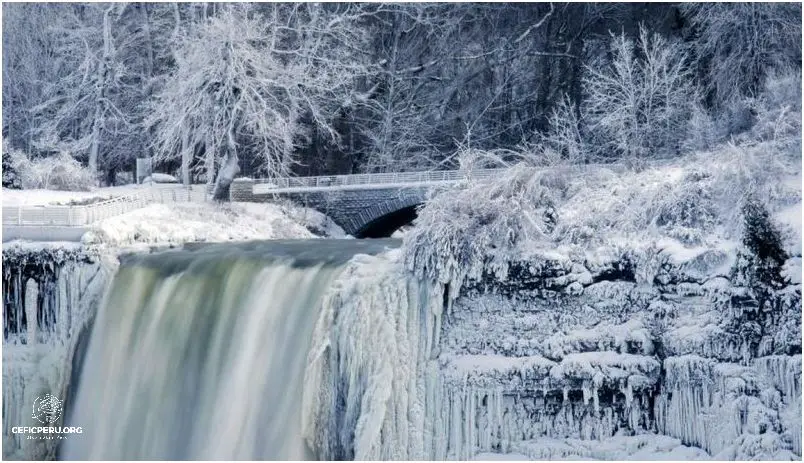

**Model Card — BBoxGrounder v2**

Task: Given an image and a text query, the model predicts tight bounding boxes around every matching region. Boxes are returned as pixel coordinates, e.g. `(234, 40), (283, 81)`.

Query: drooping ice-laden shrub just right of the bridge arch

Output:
(404, 164), (557, 295)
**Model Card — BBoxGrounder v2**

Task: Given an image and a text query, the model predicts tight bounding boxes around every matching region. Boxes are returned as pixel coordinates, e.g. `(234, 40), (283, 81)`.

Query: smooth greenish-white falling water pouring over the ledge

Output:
(61, 240), (395, 460)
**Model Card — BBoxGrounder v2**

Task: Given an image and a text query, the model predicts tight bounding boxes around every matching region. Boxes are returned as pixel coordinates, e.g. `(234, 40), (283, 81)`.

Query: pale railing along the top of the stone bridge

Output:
(254, 169), (504, 191)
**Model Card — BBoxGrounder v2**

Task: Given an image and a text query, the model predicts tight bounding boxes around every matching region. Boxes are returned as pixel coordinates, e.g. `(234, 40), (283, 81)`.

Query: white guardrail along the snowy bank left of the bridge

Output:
(3, 185), (206, 227)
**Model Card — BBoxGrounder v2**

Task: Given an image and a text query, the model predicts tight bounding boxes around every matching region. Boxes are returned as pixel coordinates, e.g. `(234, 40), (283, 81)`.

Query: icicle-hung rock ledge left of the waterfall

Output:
(3, 245), (116, 460)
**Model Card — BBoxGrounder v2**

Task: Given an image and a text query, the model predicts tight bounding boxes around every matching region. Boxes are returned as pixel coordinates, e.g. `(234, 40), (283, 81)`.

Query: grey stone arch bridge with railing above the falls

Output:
(230, 169), (504, 238)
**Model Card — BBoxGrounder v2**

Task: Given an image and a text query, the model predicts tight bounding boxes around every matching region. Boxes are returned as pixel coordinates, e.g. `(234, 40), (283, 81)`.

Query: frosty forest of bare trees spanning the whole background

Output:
(2, 3), (801, 196)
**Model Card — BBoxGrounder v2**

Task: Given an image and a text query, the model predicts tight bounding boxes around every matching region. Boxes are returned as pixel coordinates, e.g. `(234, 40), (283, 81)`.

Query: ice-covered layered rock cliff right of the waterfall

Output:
(305, 239), (801, 459)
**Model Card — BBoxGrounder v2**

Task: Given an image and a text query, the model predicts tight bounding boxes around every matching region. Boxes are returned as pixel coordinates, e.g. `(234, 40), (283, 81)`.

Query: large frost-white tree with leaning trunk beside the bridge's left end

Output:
(148, 4), (362, 198)
